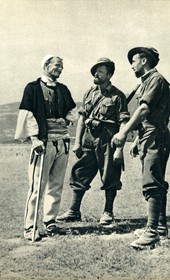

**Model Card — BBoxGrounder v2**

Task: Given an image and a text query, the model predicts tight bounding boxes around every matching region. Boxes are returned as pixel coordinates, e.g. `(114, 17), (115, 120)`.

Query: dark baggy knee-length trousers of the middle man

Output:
(70, 138), (122, 191)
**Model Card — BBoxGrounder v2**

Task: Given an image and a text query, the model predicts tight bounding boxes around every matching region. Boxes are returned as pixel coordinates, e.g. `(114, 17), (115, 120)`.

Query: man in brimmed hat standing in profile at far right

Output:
(113, 47), (170, 248)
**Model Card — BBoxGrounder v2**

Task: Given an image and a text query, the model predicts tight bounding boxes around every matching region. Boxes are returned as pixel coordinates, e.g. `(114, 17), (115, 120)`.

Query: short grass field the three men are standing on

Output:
(0, 143), (170, 280)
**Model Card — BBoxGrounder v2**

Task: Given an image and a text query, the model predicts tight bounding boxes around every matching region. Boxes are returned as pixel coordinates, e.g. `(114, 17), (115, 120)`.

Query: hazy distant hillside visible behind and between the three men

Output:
(0, 99), (136, 144)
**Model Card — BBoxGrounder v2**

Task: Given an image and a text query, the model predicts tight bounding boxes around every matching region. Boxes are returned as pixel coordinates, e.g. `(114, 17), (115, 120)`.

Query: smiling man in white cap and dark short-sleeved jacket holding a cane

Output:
(15, 54), (78, 240)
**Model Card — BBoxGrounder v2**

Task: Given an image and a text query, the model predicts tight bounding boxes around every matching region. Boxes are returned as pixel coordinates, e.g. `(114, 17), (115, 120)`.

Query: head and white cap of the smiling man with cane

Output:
(45, 57), (63, 80)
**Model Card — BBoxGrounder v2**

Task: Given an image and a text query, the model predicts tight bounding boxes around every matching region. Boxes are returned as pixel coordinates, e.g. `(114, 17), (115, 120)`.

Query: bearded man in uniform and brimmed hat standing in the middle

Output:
(57, 57), (129, 225)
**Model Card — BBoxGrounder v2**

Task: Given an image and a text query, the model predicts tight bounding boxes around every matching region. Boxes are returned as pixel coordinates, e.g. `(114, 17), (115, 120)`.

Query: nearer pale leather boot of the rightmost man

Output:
(130, 227), (160, 249)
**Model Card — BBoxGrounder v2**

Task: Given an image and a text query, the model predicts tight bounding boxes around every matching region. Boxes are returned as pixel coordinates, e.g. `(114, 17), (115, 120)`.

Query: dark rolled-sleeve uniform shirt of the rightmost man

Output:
(137, 68), (170, 139)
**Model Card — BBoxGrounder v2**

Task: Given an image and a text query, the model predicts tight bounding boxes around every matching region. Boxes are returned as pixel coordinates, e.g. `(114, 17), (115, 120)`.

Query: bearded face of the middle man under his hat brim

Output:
(94, 65), (111, 85)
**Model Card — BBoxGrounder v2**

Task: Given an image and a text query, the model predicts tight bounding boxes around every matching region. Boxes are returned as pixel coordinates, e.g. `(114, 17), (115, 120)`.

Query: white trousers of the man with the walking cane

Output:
(24, 140), (68, 229)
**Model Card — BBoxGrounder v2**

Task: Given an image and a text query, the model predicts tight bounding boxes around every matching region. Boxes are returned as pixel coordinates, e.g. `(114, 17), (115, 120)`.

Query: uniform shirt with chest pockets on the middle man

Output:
(79, 83), (129, 147)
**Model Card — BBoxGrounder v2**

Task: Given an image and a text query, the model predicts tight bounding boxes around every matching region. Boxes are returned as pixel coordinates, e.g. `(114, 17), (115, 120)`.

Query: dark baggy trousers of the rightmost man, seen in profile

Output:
(140, 126), (170, 200)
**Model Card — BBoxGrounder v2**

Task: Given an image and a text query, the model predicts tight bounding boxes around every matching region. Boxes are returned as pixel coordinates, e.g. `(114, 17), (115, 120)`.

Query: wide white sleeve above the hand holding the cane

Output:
(14, 109), (39, 141)
